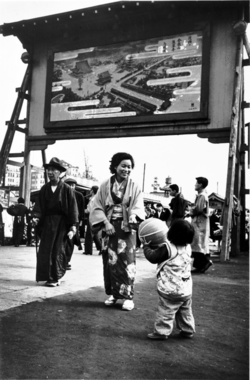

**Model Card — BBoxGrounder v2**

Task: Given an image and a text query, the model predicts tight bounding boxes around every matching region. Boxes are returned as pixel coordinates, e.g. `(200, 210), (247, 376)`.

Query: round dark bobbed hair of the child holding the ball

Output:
(168, 219), (194, 245)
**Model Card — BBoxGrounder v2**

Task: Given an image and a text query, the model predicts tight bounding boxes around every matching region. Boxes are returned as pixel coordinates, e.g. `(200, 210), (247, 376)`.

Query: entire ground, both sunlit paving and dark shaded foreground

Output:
(0, 247), (249, 380)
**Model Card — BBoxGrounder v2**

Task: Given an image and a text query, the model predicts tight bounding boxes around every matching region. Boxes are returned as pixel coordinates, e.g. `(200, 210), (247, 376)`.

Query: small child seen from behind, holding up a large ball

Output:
(142, 220), (195, 340)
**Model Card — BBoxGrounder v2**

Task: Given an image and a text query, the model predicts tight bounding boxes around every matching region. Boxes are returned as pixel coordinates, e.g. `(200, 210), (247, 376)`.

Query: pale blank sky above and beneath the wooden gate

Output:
(0, 0), (250, 207)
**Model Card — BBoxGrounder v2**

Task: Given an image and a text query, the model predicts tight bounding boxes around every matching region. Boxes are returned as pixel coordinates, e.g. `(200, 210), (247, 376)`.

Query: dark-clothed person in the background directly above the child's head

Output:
(169, 184), (187, 224)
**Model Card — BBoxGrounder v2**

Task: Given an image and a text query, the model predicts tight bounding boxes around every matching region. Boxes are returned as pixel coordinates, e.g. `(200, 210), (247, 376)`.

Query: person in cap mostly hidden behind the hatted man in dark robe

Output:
(64, 178), (85, 270)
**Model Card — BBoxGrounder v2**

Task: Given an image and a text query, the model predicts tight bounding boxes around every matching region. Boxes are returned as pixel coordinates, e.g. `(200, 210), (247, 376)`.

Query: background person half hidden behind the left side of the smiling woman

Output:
(83, 186), (102, 255)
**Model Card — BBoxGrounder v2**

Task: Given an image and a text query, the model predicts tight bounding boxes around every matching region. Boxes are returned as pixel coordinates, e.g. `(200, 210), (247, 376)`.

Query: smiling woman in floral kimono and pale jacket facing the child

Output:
(89, 153), (145, 310)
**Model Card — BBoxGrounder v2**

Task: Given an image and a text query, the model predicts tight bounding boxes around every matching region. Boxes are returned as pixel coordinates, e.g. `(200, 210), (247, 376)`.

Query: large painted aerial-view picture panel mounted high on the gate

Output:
(46, 30), (207, 127)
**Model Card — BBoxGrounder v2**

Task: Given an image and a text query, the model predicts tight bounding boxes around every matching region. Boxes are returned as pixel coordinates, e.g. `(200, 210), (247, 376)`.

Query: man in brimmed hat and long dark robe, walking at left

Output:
(33, 157), (78, 287)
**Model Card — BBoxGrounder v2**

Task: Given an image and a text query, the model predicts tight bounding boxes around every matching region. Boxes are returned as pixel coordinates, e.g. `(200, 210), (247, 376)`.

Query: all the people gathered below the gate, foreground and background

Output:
(0, 152), (221, 339)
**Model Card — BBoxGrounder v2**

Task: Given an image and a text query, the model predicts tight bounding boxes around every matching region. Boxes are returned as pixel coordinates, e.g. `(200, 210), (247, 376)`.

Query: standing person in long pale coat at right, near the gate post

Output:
(189, 177), (213, 273)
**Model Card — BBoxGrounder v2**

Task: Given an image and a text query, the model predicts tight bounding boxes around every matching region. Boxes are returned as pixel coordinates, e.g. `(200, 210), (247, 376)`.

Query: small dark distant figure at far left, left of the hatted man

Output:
(7, 197), (29, 247)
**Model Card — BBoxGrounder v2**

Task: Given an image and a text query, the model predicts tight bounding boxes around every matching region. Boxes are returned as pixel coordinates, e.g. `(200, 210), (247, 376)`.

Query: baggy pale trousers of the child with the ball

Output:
(154, 295), (195, 336)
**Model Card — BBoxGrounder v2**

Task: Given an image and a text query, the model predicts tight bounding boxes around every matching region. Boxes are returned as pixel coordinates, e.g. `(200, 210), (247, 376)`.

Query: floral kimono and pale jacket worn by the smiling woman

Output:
(89, 179), (145, 300)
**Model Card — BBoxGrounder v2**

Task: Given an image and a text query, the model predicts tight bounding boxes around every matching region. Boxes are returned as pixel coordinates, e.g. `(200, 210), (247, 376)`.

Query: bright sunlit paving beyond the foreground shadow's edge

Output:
(0, 246), (155, 311)
